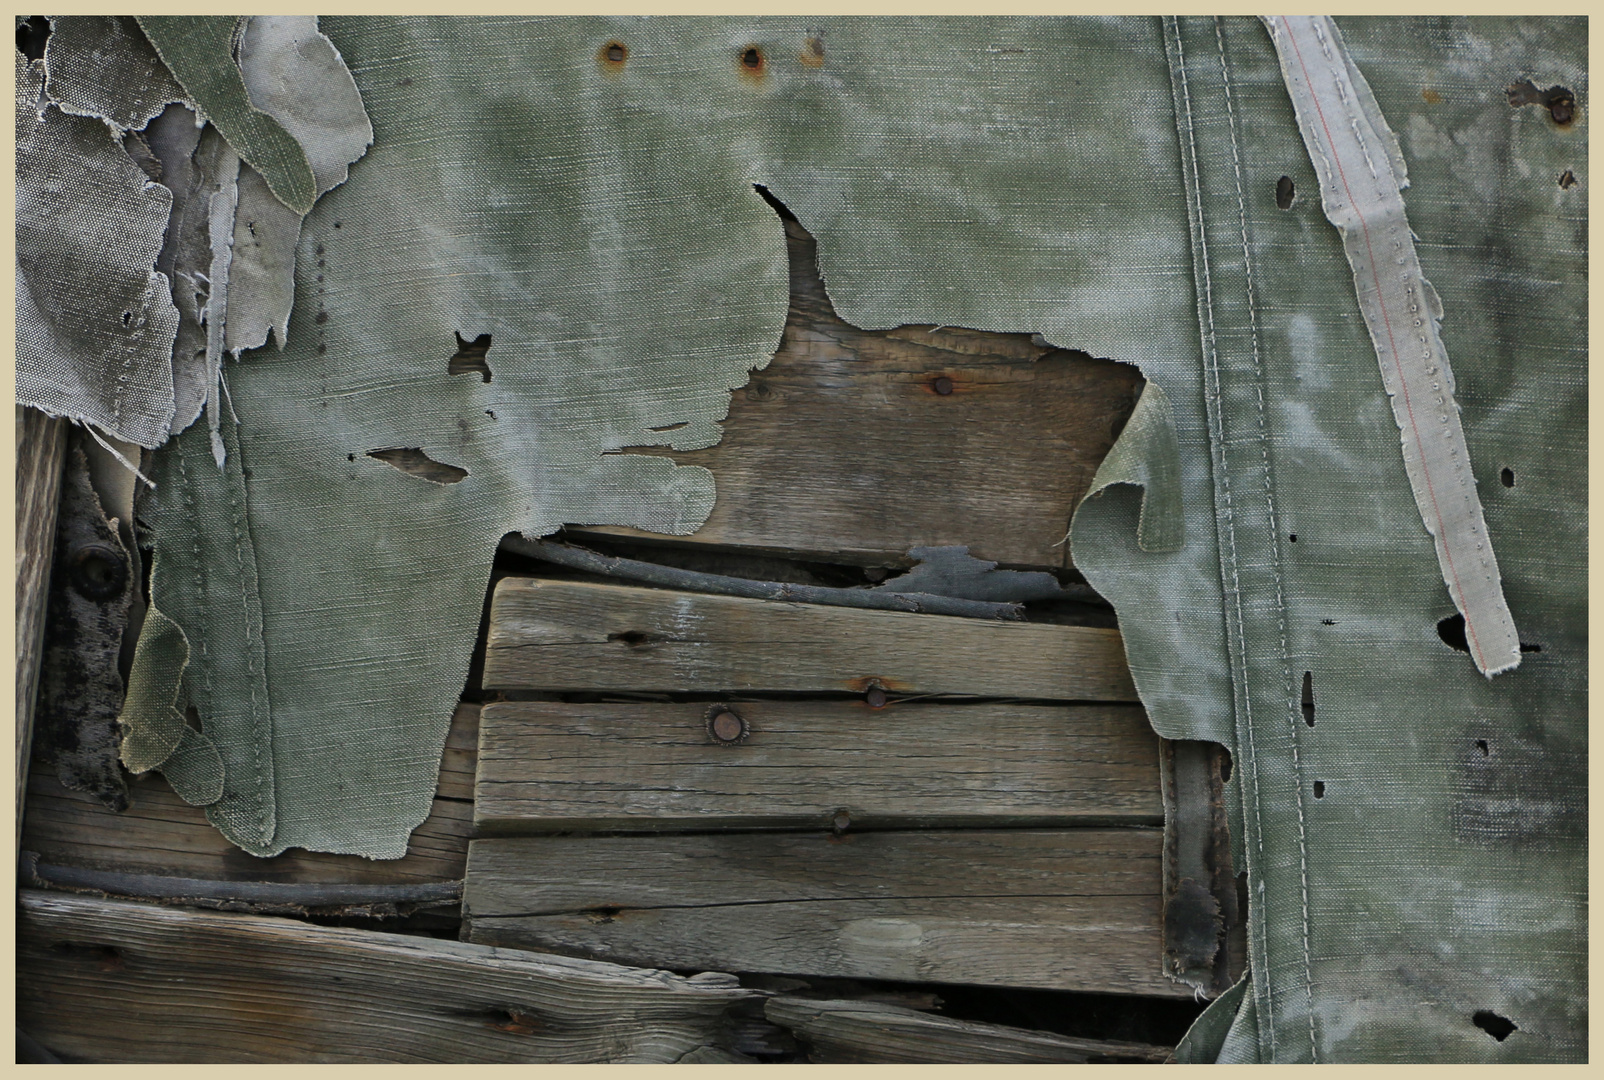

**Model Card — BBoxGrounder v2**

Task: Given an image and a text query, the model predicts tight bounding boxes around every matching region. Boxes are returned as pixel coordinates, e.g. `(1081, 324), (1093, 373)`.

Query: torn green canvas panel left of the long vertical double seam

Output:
(137, 18), (1193, 857)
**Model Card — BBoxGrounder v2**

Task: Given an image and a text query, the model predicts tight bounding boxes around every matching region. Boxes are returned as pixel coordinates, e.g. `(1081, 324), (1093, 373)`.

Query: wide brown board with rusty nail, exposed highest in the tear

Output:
(574, 213), (1140, 566)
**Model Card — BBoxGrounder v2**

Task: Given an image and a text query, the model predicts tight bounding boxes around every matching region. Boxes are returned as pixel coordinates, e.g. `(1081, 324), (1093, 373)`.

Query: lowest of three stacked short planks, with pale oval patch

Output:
(464, 828), (1192, 997)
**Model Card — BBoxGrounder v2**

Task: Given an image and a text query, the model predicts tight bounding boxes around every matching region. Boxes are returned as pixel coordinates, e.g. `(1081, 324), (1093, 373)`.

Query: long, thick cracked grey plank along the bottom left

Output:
(18, 891), (751, 1062)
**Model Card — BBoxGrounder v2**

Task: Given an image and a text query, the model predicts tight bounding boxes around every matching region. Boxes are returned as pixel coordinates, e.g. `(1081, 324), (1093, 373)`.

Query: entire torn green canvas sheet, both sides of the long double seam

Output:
(109, 18), (1586, 1062)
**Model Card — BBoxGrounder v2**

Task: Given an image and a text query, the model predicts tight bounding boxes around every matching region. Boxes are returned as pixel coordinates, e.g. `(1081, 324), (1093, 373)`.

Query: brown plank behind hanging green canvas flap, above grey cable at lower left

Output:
(22, 704), (480, 884)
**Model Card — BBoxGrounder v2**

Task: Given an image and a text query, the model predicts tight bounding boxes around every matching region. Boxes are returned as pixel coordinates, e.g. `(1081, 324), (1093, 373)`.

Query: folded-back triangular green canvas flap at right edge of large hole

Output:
(1070, 382), (1187, 552)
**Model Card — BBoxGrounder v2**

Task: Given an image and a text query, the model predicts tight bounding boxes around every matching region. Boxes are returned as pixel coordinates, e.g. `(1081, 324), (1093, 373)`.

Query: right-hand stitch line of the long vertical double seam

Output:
(1214, 16), (1320, 1061)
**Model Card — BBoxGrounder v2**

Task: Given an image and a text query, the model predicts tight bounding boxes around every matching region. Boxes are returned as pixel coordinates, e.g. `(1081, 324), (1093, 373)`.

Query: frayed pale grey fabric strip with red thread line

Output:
(1264, 16), (1521, 679)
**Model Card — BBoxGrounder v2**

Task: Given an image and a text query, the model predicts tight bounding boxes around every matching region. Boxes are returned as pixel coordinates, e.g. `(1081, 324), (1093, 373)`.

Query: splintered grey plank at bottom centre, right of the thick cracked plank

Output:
(764, 998), (1173, 1066)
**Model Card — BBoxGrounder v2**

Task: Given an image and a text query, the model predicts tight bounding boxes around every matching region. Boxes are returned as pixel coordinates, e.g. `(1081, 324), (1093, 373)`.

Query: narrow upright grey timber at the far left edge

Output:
(16, 406), (67, 838)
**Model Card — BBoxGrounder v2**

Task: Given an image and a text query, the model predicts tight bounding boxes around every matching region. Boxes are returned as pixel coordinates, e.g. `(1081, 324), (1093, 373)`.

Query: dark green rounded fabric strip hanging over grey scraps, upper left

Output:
(140, 14), (318, 213)
